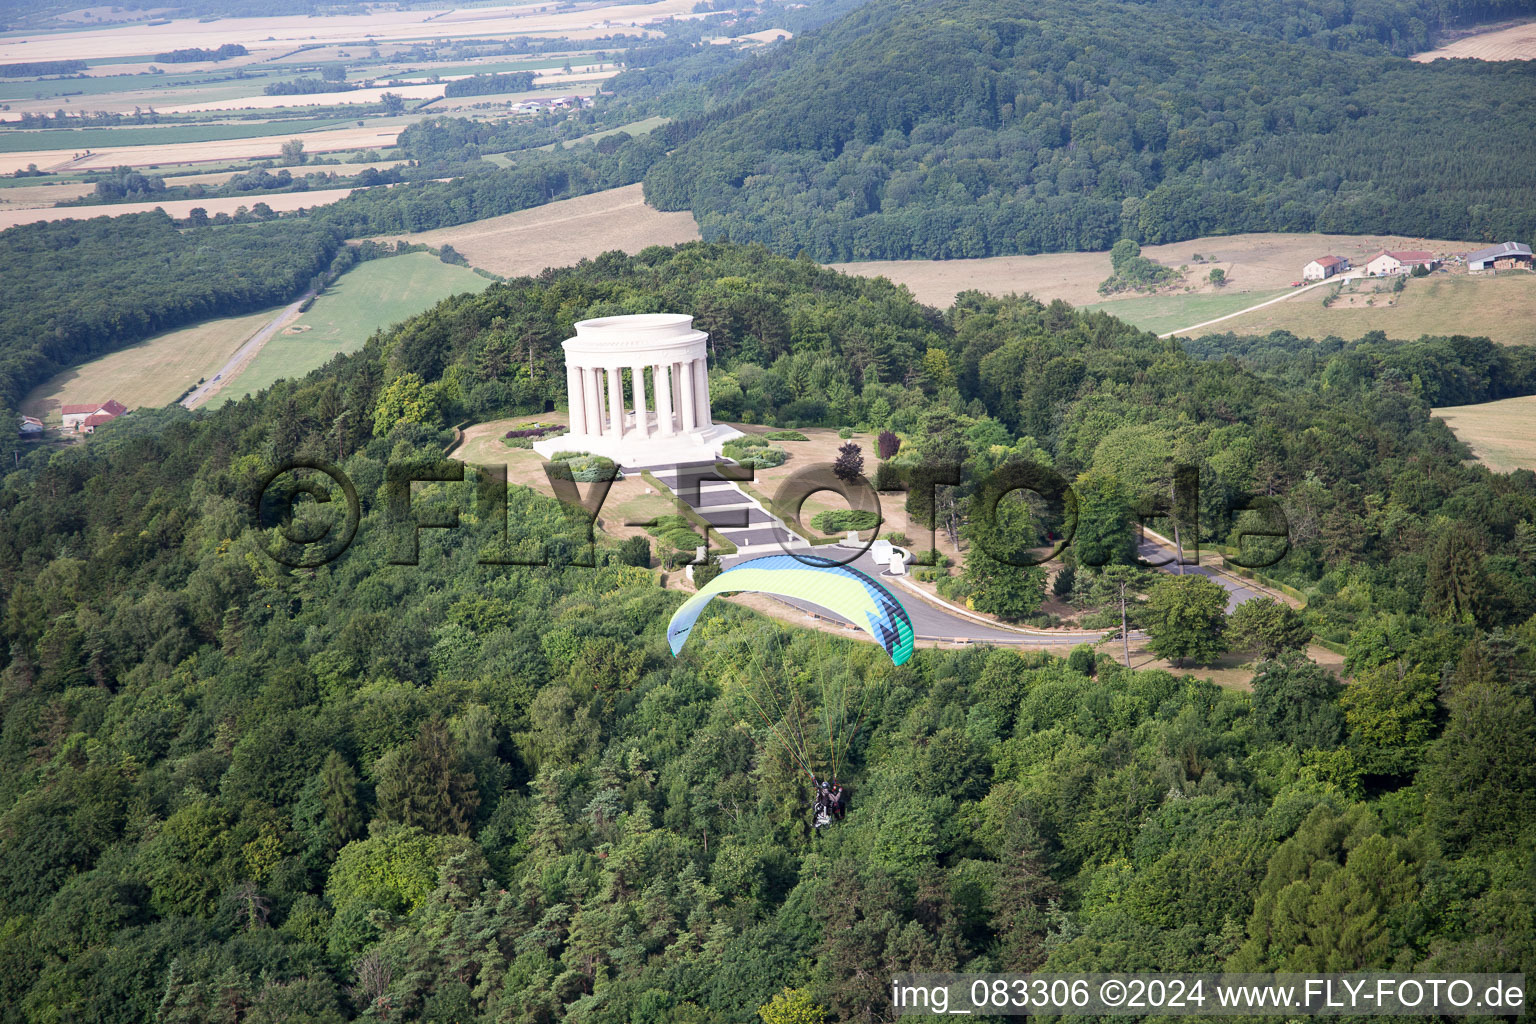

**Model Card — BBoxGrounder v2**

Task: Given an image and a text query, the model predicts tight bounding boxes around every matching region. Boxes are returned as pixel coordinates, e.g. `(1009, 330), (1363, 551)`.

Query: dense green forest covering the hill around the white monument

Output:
(0, 244), (1536, 1024)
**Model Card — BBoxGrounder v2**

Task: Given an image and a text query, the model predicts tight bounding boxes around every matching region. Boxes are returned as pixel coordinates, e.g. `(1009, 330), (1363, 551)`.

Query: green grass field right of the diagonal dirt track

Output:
(207, 252), (490, 408)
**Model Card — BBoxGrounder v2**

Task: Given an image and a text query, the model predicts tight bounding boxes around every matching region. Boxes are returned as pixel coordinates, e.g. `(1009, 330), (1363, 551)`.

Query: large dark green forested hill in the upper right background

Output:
(645, 0), (1536, 261)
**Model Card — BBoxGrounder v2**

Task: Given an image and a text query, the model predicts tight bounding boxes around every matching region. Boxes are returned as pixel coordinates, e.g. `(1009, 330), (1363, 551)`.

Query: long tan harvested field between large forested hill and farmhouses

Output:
(831, 232), (1487, 312)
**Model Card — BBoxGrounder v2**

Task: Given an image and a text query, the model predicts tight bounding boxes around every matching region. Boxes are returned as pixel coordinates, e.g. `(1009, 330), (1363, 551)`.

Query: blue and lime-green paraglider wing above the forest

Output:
(667, 554), (914, 665)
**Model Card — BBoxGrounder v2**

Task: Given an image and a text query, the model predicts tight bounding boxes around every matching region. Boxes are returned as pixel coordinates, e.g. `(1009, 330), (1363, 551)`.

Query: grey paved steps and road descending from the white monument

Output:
(651, 467), (1264, 646)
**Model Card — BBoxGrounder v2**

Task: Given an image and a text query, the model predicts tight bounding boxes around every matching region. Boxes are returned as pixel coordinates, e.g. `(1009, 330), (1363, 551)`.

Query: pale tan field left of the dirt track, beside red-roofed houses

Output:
(22, 309), (276, 425)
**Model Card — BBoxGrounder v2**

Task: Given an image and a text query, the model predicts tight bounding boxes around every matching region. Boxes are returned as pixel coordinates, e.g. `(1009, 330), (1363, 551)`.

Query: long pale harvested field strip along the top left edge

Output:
(0, 0), (694, 64)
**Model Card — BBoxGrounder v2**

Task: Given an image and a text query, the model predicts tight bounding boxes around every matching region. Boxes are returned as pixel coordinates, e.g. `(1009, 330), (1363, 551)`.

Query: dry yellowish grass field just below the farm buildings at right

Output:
(1195, 272), (1536, 345)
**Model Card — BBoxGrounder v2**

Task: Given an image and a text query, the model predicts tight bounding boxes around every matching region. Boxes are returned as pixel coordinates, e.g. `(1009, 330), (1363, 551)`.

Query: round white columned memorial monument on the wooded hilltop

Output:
(533, 313), (742, 467)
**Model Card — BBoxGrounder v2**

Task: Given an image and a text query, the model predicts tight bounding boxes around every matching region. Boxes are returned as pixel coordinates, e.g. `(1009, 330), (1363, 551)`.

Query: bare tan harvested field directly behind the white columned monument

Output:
(374, 184), (699, 278)
